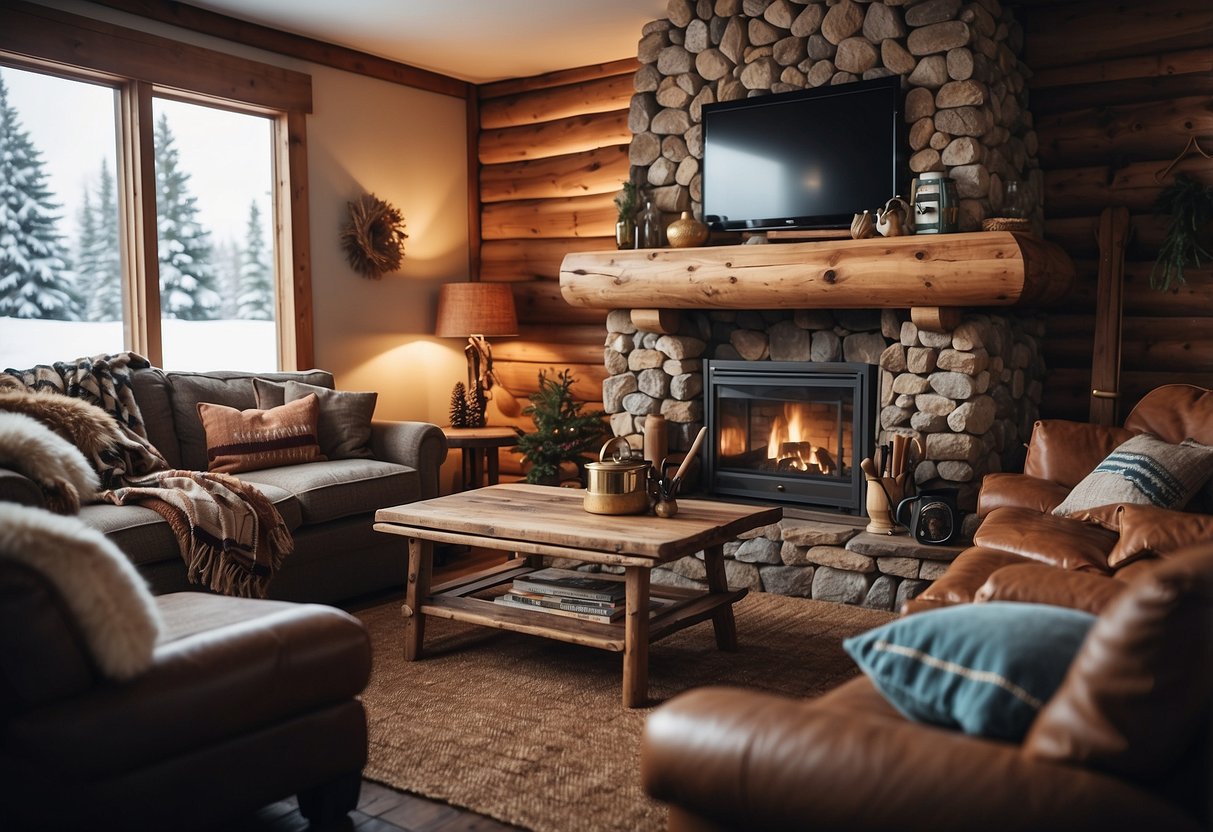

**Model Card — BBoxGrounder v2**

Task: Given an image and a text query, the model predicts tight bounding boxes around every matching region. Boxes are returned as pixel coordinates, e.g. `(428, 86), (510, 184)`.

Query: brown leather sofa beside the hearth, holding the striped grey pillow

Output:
(902, 384), (1213, 614)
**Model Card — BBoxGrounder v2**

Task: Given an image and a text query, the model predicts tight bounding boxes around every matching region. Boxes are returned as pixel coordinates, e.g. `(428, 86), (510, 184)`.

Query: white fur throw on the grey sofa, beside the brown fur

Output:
(0, 411), (101, 514)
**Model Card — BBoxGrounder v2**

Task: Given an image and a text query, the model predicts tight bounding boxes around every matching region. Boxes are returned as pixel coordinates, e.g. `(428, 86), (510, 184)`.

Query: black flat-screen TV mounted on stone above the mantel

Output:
(704, 75), (907, 230)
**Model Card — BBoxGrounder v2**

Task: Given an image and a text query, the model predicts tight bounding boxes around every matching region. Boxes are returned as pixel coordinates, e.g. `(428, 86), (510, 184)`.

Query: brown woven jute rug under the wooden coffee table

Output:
(358, 593), (893, 832)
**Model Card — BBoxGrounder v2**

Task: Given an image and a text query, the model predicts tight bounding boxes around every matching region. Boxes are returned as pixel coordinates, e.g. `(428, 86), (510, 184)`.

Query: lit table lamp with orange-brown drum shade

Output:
(435, 283), (519, 427)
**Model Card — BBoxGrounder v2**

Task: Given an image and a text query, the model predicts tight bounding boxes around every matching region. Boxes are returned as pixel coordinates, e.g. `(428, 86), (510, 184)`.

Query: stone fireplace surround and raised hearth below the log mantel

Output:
(603, 303), (1044, 609)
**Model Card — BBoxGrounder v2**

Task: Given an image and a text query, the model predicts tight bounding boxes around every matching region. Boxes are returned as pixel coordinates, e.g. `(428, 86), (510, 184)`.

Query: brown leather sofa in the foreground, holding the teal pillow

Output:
(640, 545), (1213, 832)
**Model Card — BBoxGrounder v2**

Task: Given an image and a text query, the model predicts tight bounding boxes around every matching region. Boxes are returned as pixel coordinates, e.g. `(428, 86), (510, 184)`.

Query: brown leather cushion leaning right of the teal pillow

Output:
(1024, 543), (1213, 780)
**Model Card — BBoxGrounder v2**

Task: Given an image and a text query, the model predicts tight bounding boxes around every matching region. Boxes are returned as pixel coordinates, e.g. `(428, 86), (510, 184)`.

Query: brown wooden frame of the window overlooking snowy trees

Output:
(0, 2), (314, 370)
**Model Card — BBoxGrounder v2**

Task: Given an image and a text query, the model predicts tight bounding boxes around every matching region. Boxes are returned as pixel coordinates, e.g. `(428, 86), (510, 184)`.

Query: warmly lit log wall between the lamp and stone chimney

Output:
(478, 58), (638, 479)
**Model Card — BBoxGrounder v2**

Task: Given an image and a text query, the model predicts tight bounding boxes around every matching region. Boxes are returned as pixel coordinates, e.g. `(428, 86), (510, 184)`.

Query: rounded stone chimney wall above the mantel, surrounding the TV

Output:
(628, 0), (1043, 230)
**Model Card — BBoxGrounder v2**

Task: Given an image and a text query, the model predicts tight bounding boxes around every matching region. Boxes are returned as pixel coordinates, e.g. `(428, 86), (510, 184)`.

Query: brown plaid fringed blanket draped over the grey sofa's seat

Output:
(102, 471), (292, 598)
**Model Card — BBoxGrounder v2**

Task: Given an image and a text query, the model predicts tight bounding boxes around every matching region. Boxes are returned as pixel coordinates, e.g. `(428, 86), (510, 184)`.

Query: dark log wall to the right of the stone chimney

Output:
(1016, 0), (1213, 423)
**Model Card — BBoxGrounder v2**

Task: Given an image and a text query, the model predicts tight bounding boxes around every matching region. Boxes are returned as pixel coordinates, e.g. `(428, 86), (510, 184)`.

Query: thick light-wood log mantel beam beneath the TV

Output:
(560, 232), (1075, 309)
